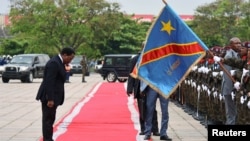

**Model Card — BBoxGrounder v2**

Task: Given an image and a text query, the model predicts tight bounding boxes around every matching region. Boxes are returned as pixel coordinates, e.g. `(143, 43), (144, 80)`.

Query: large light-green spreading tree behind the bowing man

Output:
(6, 0), (122, 54)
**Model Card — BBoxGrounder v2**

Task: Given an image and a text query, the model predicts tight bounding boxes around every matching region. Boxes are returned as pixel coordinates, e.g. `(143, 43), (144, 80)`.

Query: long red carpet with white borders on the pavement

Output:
(46, 82), (143, 141)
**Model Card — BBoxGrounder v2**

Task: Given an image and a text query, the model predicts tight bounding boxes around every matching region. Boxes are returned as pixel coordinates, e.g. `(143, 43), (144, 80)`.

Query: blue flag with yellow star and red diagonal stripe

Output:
(137, 4), (208, 98)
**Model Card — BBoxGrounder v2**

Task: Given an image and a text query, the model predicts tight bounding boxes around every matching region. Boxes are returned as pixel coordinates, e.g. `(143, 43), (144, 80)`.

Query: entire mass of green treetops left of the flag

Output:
(2, 0), (151, 58)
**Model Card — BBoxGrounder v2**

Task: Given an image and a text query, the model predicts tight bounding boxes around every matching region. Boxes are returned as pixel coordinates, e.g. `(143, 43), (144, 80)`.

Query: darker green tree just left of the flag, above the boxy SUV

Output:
(103, 15), (151, 54)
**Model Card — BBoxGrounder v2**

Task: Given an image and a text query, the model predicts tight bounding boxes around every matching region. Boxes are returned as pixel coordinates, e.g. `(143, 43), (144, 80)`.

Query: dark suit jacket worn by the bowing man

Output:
(36, 55), (66, 106)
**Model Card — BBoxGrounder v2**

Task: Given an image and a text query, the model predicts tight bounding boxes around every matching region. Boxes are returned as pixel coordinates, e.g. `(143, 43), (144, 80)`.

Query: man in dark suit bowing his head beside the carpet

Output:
(36, 47), (75, 141)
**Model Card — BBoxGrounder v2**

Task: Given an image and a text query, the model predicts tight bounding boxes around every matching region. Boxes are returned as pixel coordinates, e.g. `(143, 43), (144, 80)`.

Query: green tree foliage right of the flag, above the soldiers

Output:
(192, 0), (250, 47)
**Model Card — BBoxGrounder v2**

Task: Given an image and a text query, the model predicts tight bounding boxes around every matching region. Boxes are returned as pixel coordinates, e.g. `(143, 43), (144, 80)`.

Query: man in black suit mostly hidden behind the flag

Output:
(127, 43), (160, 136)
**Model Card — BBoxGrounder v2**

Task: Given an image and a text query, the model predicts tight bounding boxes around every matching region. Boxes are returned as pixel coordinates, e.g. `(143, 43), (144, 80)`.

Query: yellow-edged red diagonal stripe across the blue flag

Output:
(141, 43), (204, 65)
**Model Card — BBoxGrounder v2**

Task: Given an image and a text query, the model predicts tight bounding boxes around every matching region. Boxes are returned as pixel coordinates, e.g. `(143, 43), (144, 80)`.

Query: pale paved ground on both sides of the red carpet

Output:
(0, 74), (207, 141)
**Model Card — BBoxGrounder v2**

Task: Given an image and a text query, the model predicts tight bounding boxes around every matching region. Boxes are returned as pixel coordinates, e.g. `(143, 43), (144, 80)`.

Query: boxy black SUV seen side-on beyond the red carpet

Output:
(100, 54), (136, 82)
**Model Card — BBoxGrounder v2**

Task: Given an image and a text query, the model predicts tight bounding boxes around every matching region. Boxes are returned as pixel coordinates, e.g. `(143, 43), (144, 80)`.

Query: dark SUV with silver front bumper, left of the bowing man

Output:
(2, 54), (50, 83)
